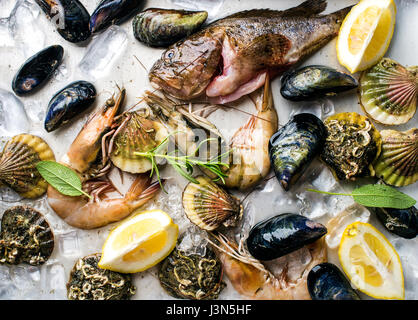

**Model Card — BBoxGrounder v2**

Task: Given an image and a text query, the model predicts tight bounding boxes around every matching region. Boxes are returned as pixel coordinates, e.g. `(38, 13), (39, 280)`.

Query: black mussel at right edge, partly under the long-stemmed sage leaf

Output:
(368, 207), (418, 239)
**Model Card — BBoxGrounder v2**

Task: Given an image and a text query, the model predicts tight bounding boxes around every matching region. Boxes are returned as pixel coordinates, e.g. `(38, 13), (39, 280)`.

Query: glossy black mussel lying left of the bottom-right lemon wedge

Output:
(246, 213), (327, 261)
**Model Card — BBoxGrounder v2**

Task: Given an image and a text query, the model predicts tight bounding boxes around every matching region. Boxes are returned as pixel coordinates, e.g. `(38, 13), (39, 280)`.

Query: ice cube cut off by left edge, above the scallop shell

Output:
(0, 89), (30, 136)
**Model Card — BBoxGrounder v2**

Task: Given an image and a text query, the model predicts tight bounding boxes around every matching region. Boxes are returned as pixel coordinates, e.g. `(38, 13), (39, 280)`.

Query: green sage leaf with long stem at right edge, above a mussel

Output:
(307, 184), (416, 209)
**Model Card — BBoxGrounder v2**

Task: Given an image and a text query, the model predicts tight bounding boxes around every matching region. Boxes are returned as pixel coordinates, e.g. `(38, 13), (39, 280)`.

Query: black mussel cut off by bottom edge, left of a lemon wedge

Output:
(307, 262), (360, 300)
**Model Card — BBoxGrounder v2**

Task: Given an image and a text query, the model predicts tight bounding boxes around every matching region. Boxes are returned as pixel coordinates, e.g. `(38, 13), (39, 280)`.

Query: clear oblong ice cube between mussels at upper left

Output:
(78, 25), (128, 80)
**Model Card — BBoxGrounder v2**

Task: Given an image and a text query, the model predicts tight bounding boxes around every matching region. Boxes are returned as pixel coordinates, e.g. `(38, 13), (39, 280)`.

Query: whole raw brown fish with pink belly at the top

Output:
(149, 0), (351, 103)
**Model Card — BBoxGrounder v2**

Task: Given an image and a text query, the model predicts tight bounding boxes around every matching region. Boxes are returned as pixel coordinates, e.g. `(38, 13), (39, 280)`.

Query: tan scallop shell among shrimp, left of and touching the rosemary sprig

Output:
(110, 111), (168, 173)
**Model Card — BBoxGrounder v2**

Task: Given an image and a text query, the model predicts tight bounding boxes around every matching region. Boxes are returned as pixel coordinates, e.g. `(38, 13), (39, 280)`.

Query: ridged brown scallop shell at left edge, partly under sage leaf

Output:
(0, 134), (55, 199)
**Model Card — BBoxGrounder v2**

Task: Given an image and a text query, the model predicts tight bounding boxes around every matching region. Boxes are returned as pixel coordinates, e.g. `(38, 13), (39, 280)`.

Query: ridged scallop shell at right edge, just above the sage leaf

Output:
(373, 128), (418, 187)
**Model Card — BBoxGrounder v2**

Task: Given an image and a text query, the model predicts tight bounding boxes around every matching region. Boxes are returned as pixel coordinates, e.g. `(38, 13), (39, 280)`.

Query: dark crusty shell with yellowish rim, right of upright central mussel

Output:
(321, 112), (382, 180)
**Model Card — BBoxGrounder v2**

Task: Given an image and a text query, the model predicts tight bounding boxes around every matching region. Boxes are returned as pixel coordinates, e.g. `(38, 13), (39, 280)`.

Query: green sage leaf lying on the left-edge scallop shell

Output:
(36, 161), (91, 198)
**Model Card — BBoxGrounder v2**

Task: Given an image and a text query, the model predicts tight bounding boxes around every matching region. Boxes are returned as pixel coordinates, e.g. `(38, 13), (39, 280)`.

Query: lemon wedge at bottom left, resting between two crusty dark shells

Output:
(98, 210), (179, 273)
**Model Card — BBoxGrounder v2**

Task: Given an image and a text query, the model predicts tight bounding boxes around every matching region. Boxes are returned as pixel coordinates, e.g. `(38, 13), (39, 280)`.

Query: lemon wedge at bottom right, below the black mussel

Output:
(338, 222), (405, 299)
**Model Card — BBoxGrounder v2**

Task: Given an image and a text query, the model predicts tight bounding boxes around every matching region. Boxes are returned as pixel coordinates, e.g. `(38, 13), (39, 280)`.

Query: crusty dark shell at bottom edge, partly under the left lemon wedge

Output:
(67, 253), (136, 300)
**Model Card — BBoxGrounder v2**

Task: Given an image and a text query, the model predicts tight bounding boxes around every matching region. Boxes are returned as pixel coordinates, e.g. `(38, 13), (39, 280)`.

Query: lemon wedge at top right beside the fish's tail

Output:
(337, 0), (396, 73)
